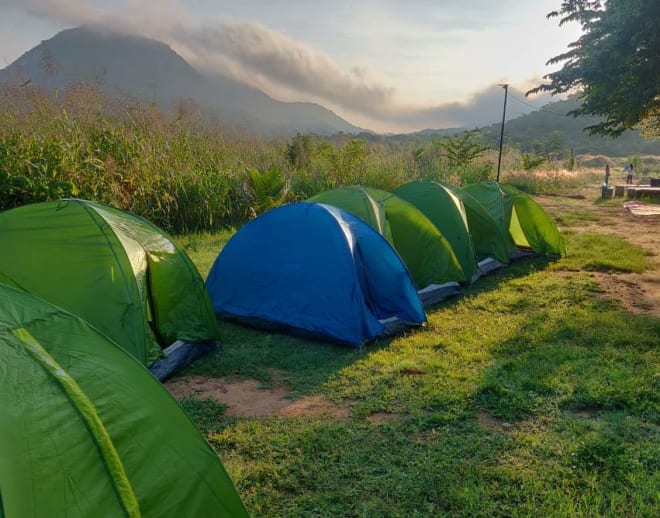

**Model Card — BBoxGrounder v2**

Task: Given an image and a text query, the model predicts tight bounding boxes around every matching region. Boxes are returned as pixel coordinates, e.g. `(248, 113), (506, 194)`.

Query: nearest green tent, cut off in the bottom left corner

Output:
(0, 284), (247, 518)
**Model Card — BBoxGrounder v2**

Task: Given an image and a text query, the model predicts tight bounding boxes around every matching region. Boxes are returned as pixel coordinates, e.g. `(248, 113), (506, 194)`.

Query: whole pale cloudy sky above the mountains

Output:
(0, 0), (580, 132)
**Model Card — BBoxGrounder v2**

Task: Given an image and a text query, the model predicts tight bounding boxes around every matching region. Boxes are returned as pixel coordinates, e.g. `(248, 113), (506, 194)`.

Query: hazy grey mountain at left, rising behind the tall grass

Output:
(0, 27), (361, 135)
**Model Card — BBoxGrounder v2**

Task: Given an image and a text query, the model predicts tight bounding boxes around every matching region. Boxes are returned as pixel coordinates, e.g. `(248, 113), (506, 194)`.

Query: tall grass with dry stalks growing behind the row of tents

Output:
(0, 85), (624, 233)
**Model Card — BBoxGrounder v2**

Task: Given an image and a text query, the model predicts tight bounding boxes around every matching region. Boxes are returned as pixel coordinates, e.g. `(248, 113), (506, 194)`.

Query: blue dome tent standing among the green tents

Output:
(206, 203), (426, 347)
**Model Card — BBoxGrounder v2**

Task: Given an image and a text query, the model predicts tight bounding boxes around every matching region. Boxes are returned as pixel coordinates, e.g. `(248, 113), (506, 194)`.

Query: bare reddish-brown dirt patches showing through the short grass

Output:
(166, 187), (660, 420)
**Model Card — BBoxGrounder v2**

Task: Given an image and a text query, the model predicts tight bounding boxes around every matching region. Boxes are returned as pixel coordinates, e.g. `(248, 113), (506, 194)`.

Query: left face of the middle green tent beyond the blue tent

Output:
(393, 182), (479, 279)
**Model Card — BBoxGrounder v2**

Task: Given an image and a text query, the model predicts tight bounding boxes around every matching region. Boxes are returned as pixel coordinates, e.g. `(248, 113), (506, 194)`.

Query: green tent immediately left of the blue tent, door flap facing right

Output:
(0, 199), (217, 364)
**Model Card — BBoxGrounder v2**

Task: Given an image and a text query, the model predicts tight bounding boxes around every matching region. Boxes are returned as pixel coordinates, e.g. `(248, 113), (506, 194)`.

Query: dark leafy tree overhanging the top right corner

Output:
(527, 0), (660, 137)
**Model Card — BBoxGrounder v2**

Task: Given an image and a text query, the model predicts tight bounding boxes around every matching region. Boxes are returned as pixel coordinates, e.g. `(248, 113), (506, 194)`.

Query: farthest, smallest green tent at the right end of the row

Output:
(465, 182), (564, 255)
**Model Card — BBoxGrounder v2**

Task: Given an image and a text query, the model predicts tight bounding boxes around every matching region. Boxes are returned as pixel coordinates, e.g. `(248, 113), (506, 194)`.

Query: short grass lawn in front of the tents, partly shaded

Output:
(169, 187), (660, 517)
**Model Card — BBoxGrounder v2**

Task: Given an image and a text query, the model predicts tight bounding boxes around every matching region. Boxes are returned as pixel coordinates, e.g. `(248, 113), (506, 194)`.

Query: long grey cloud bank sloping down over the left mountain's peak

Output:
(4, 0), (395, 111)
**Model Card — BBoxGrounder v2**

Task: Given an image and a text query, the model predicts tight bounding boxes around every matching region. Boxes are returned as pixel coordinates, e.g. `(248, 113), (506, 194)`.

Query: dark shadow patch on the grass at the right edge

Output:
(476, 303), (660, 423)
